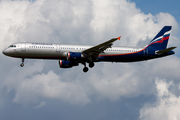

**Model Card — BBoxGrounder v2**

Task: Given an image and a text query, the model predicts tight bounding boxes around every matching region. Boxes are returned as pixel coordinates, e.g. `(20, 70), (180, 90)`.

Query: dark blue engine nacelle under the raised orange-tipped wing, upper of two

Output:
(67, 52), (84, 61)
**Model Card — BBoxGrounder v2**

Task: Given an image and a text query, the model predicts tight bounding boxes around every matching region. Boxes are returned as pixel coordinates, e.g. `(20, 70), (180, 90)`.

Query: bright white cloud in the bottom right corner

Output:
(140, 79), (180, 120)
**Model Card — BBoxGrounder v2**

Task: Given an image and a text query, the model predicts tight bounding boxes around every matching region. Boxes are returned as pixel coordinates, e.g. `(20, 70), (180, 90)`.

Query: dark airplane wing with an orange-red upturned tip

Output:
(82, 36), (121, 58)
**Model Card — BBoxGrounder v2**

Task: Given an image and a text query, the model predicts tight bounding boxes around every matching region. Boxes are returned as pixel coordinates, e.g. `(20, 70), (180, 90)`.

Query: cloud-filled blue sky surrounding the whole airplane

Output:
(0, 0), (180, 120)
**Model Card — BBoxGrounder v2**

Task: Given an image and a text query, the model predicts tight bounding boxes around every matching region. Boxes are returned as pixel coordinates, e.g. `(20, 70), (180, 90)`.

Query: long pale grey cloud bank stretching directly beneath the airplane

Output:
(1, 56), (180, 105)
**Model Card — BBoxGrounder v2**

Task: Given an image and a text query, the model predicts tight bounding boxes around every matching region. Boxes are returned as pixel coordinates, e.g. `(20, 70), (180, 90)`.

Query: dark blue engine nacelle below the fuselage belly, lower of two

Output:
(59, 60), (78, 68)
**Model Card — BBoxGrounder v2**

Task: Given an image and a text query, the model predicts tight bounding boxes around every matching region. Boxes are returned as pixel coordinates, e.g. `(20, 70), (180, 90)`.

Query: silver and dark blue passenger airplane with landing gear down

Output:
(3, 26), (176, 72)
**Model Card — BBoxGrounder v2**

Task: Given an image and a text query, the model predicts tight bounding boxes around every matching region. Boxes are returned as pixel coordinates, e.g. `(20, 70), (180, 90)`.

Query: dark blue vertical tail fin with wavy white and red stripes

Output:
(147, 26), (172, 50)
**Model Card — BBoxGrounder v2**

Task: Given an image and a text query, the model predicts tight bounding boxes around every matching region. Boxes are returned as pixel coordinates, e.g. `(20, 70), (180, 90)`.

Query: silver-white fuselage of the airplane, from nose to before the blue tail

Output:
(3, 43), (142, 59)
